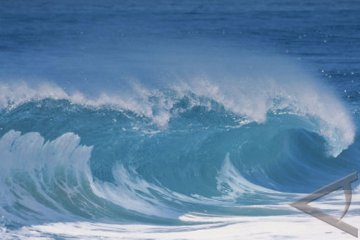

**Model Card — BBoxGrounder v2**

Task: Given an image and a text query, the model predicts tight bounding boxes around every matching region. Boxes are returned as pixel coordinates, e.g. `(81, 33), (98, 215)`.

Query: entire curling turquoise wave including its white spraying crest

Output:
(0, 79), (359, 227)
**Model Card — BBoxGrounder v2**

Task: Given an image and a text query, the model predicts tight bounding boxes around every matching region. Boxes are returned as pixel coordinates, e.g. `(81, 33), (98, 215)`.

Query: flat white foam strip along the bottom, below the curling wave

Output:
(2, 216), (359, 240)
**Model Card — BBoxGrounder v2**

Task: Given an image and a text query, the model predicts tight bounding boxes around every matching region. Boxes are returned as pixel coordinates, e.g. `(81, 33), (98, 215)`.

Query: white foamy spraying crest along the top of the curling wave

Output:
(0, 77), (355, 157)
